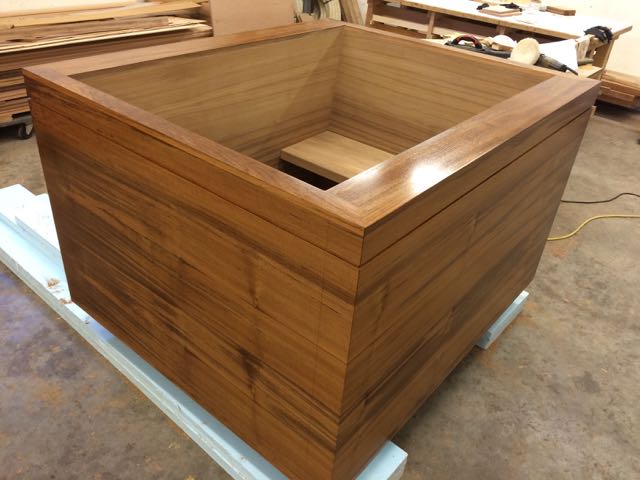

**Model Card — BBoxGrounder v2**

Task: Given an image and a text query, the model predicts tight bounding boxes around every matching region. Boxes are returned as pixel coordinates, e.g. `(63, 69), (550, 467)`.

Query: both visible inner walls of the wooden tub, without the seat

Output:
(75, 27), (552, 176)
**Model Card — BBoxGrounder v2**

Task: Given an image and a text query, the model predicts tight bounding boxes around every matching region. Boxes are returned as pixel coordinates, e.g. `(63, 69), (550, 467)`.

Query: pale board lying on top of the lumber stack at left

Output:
(0, 0), (200, 28)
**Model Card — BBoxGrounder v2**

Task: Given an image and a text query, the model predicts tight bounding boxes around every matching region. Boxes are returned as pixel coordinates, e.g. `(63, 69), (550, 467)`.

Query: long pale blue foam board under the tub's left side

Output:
(0, 185), (407, 480)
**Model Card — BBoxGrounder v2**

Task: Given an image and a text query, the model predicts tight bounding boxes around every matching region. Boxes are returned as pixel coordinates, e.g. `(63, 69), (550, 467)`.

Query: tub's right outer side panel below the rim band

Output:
(336, 110), (591, 478)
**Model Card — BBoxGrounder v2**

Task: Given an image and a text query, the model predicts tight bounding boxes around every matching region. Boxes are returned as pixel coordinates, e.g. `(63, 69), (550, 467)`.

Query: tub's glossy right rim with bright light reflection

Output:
(330, 76), (599, 263)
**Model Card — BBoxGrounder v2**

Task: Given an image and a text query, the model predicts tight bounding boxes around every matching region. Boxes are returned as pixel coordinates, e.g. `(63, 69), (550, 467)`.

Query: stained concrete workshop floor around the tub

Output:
(0, 110), (640, 480)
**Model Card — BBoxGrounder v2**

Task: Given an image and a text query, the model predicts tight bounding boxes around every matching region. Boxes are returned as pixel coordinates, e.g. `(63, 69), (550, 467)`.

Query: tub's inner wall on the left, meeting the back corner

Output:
(75, 28), (340, 165)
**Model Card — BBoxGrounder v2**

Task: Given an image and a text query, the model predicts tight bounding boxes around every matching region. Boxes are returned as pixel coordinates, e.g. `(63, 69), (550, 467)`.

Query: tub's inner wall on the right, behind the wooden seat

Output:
(330, 28), (553, 153)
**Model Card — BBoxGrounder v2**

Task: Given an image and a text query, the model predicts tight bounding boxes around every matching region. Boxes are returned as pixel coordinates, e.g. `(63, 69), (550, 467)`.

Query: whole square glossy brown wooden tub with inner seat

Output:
(25, 22), (598, 480)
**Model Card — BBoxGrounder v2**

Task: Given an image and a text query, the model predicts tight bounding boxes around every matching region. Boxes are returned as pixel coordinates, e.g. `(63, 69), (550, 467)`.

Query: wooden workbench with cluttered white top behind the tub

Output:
(366, 0), (632, 78)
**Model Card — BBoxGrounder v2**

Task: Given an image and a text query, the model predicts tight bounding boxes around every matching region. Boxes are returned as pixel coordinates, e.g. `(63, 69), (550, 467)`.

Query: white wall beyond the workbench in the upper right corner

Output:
(547, 0), (640, 77)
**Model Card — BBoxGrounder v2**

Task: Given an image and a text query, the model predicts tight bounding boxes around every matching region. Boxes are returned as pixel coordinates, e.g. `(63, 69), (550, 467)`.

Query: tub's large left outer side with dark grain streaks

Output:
(29, 81), (357, 479)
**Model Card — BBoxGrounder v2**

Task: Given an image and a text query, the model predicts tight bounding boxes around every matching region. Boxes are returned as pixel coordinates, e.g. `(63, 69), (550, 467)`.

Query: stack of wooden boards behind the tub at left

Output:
(0, 0), (211, 124)
